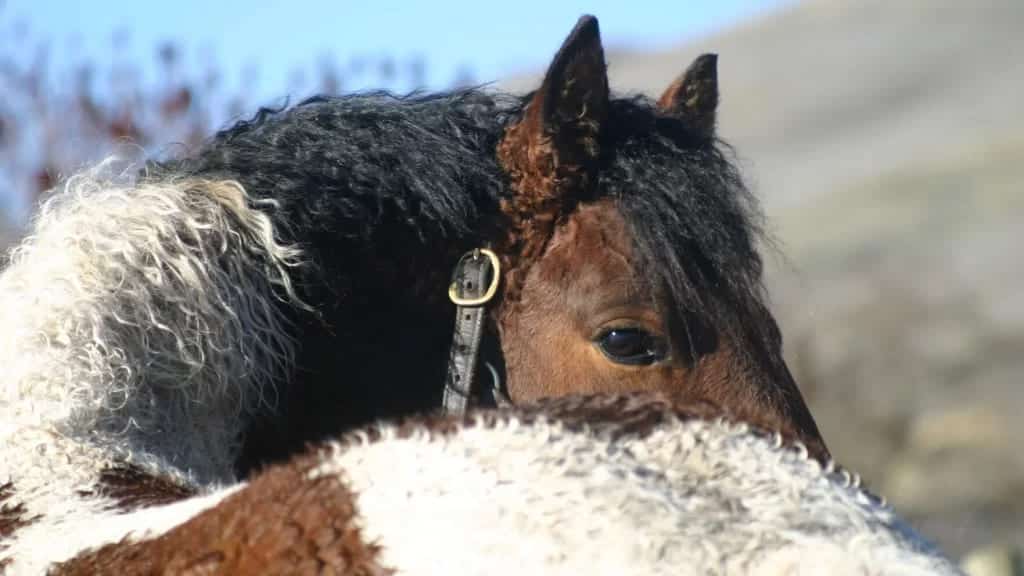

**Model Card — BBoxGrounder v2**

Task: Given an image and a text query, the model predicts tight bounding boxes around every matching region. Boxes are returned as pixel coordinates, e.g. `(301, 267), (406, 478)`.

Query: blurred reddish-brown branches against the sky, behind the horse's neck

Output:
(0, 21), (473, 215)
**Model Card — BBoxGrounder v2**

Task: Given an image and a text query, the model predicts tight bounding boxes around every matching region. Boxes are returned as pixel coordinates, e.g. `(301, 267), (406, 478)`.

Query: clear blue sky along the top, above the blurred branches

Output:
(0, 0), (788, 99)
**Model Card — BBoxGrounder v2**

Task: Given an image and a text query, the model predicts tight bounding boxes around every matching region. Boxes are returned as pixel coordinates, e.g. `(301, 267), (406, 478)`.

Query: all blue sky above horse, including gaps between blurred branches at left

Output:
(0, 0), (793, 218)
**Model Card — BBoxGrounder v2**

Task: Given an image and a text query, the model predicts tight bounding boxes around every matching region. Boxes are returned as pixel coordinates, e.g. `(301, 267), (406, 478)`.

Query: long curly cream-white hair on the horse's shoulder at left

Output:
(0, 167), (302, 494)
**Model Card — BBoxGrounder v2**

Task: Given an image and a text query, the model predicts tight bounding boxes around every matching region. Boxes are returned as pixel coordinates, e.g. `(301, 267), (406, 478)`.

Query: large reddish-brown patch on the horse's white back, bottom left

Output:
(51, 456), (391, 576)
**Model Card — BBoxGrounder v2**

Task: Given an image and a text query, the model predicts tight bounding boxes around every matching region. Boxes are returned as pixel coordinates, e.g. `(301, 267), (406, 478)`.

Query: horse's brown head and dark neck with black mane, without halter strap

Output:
(154, 17), (827, 474)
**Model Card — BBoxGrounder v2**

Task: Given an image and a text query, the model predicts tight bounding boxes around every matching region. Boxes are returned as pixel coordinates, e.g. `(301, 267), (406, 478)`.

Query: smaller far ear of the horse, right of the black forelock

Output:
(657, 54), (718, 138)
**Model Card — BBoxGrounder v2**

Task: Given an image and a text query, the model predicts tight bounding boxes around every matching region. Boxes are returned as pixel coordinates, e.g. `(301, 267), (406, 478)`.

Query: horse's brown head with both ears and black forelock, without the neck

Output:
(487, 16), (827, 457)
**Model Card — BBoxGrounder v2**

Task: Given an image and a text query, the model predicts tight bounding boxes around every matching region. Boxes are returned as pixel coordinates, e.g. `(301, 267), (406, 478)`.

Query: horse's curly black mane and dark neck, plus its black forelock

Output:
(150, 85), (781, 471)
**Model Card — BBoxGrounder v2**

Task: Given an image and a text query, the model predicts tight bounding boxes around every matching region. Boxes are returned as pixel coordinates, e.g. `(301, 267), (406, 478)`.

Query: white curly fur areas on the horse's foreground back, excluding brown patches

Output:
(2, 412), (959, 576)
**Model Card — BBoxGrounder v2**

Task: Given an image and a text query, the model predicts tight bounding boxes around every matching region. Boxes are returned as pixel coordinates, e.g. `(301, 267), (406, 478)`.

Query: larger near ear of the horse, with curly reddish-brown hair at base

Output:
(498, 15), (609, 260)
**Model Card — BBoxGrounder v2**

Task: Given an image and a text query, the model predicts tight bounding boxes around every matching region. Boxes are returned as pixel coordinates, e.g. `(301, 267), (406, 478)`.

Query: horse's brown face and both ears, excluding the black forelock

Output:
(496, 20), (827, 456)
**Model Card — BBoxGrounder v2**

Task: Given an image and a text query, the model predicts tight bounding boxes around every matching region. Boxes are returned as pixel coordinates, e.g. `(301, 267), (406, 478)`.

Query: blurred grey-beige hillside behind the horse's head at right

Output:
(507, 0), (1024, 554)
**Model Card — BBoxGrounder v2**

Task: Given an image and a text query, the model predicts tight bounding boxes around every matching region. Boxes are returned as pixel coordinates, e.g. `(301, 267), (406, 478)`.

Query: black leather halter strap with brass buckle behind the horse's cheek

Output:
(441, 248), (501, 415)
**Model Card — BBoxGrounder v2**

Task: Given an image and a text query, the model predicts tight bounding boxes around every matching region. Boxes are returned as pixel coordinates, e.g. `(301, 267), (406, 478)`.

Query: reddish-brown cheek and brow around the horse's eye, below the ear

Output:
(500, 202), (679, 401)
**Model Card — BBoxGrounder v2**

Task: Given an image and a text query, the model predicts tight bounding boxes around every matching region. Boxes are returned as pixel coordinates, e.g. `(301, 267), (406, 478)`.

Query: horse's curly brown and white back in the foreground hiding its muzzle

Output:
(18, 394), (957, 576)
